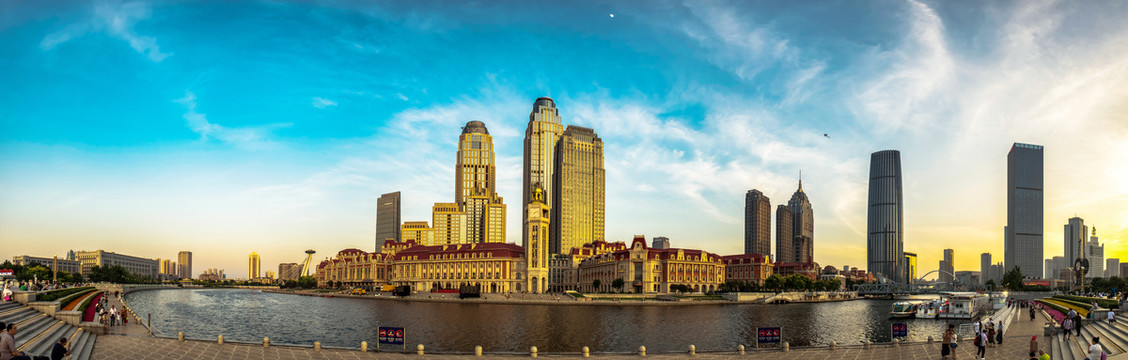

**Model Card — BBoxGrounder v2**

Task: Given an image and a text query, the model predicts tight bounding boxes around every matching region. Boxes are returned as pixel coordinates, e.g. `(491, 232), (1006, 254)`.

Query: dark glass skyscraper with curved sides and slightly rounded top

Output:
(866, 150), (906, 283)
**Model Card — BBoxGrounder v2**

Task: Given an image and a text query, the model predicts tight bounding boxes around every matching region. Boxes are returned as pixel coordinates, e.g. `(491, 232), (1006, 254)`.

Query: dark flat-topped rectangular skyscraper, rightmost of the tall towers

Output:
(1003, 142), (1043, 279)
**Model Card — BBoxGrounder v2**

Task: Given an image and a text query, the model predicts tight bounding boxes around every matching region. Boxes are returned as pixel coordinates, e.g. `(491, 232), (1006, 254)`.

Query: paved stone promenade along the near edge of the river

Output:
(91, 311), (1049, 360)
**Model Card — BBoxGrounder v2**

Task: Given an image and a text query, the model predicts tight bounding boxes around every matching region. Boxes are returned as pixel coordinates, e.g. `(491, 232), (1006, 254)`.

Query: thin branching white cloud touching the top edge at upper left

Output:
(39, 2), (171, 62)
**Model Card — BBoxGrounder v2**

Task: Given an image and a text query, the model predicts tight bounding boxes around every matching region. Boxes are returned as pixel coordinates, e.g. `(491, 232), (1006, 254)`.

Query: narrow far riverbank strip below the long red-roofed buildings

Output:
(262, 289), (865, 306)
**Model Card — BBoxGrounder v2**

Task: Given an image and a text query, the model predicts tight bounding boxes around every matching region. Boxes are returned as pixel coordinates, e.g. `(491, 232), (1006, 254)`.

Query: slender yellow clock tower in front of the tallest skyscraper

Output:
(522, 186), (550, 293)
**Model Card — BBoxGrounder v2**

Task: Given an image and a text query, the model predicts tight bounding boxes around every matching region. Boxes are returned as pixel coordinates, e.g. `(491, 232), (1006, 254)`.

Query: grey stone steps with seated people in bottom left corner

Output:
(0, 301), (97, 360)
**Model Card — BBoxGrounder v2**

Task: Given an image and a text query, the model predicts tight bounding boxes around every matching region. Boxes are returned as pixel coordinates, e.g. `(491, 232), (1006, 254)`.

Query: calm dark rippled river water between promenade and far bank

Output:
(126, 289), (970, 352)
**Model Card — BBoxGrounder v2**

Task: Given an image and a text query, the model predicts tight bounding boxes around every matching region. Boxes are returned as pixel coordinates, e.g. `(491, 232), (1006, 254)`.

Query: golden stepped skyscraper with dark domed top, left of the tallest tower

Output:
(455, 121), (505, 243)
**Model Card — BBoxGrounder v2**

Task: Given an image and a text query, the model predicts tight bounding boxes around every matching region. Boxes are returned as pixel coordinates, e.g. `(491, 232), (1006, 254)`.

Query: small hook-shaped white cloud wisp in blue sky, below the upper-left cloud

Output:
(176, 91), (290, 149)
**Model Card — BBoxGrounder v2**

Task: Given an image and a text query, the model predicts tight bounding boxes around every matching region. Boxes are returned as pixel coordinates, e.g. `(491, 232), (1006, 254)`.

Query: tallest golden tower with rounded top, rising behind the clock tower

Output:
(521, 97), (564, 253)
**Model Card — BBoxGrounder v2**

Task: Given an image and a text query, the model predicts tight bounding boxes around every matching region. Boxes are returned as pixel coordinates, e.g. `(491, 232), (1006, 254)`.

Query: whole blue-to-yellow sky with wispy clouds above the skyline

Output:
(0, 0), (1128, 278)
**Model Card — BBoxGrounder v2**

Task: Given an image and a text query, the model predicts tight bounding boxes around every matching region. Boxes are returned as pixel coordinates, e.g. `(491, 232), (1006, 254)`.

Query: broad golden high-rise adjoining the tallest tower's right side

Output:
(549, 125), (606, 254)
